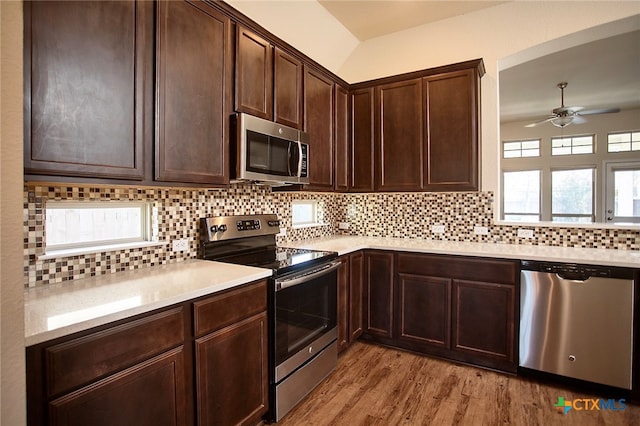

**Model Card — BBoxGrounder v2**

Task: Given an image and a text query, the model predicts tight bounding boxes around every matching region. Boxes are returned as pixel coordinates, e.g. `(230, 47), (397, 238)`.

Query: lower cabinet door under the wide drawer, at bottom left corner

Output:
(49, 346), (189, 426)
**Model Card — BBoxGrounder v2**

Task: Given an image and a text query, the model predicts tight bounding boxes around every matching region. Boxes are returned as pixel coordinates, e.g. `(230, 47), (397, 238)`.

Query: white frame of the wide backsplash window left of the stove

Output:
(44, 201), (157, 257)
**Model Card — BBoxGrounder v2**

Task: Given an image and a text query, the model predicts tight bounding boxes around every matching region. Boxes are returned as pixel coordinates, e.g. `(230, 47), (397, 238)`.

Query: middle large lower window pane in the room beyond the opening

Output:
(551, 168), (594, 223)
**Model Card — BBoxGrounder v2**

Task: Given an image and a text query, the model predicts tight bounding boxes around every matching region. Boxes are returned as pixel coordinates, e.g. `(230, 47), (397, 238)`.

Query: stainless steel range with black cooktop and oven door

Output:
(200, 215), (340, 421)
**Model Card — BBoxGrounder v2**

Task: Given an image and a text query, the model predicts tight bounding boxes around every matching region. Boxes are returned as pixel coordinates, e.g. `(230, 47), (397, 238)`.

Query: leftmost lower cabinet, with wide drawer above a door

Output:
(27, 306), (192, 426)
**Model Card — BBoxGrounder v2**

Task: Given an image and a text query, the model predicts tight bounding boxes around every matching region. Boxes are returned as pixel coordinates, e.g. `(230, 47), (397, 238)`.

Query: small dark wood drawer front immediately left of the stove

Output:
(193, 280), (267, 337)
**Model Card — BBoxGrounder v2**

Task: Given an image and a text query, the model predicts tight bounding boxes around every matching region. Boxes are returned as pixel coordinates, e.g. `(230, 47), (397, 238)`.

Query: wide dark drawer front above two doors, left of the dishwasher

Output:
(398, 253), (519, 284)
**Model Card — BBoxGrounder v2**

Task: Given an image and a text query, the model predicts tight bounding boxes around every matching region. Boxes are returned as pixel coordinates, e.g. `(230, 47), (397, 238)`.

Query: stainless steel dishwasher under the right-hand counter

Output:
(520, 261), (633, 389)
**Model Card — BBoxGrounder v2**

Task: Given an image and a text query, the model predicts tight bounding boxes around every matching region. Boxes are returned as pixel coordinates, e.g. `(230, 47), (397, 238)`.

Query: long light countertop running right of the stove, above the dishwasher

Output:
(283, 236), (640, 268)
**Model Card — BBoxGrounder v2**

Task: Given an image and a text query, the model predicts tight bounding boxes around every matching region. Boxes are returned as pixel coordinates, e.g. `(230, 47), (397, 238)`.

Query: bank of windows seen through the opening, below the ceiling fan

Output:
(501, 130), (640, 224)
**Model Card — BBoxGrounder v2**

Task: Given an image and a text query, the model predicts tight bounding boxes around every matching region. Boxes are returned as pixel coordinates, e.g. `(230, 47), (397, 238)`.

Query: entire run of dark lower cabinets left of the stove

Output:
(26, 280), (268, 426)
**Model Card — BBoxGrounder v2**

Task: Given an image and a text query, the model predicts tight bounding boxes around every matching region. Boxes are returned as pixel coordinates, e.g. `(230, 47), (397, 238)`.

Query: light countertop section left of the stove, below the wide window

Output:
(24, 260), (271, 346)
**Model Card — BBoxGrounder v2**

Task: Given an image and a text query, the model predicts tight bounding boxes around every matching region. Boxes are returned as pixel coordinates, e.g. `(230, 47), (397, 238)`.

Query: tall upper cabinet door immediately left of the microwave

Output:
(155, 1), (233, 184)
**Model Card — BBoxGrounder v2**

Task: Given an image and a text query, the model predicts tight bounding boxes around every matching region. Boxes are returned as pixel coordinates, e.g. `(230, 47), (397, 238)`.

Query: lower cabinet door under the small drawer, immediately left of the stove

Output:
(195, 313), (268, 425)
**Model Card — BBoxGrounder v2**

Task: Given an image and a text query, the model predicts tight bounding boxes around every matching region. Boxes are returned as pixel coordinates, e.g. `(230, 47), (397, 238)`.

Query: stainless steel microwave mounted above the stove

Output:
(235, 113), (309, 185)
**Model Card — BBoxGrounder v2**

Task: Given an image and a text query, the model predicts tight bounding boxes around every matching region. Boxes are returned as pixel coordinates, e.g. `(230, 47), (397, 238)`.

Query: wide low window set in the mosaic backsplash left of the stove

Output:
(45, 201), (151, 251)
